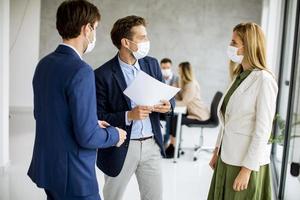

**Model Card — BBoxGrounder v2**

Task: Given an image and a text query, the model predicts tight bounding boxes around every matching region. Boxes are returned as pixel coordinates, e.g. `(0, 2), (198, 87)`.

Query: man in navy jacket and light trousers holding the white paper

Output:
(95, 16), (175, 200)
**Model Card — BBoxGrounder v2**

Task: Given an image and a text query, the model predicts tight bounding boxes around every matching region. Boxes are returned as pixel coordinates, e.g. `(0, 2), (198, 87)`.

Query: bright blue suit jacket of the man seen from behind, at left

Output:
(28, 45), (119, 196)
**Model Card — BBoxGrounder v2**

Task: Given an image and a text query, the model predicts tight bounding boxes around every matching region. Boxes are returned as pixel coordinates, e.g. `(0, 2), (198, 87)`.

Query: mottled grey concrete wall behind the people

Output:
(40, 0), (262, 104)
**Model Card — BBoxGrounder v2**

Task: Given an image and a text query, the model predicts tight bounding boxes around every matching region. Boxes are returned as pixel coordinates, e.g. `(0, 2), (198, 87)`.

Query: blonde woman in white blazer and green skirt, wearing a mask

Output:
(208, 23), (278, 200)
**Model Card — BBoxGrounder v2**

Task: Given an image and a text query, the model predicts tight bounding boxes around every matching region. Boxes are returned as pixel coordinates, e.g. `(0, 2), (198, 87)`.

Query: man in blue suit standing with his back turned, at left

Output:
(28, 0), (126, 200)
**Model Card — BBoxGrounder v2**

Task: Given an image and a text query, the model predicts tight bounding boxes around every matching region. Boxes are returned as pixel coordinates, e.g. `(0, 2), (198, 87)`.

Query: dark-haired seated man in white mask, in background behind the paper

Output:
(160, 58), (178, 146)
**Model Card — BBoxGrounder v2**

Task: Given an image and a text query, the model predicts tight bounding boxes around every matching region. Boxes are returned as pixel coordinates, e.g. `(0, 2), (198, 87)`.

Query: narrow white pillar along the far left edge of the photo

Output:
(0, 0), (9, 170)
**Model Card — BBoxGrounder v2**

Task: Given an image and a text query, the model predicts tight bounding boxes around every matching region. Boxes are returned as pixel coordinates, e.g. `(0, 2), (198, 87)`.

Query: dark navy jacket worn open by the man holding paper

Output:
(95, 55), (175, 177)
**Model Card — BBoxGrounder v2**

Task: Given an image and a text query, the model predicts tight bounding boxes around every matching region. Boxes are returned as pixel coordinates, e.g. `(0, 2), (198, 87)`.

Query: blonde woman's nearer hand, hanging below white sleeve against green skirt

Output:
(233, 167), (251, 192)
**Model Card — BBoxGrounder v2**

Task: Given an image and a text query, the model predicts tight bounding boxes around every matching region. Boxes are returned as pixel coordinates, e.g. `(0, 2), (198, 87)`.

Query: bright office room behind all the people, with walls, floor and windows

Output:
(0, 0), (300, 200)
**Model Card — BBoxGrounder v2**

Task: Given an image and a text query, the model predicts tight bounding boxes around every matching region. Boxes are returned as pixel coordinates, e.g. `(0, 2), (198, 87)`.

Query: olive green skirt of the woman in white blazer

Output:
(207, 156), (272, 200)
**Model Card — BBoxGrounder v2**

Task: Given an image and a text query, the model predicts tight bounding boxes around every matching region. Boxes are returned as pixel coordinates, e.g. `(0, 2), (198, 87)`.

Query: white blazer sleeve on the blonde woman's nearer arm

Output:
(242, 74), (278, 171)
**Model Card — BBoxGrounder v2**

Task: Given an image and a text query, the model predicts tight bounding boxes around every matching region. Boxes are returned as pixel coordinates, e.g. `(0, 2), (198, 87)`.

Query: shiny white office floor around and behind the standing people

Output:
(0, 111), (278, 200)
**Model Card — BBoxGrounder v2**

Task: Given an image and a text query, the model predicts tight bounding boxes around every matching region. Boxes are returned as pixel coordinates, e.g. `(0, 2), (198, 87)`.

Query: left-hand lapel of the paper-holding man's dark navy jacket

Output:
(112, 55), (131, 109)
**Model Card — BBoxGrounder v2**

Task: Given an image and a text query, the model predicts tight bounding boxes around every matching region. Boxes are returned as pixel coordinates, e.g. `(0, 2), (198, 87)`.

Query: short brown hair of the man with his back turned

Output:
(56, 0), (101, 39)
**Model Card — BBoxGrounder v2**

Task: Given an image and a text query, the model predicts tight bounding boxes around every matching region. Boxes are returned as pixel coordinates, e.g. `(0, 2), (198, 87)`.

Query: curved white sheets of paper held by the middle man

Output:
(124, 71), (180, 106)
